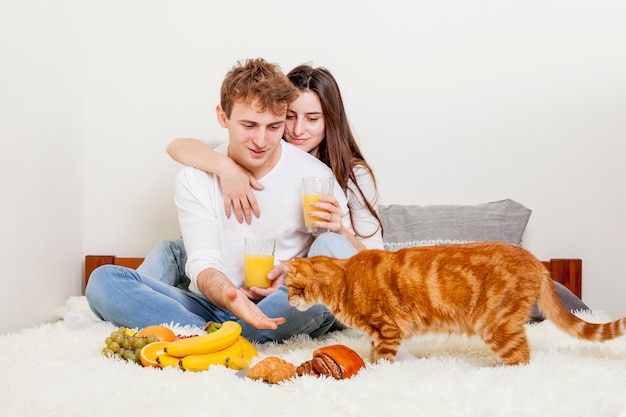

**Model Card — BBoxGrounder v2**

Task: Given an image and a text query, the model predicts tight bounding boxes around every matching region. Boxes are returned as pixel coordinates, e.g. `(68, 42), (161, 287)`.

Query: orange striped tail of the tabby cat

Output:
(538, 271), (626, 342)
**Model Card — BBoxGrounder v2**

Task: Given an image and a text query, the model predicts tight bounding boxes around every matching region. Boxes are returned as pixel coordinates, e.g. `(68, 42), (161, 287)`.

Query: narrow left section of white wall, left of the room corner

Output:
(0, 1), (85, 333)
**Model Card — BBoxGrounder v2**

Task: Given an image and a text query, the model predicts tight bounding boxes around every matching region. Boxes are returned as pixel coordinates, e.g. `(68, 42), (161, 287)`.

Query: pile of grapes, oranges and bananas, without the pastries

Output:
(102, 321), (257, 371)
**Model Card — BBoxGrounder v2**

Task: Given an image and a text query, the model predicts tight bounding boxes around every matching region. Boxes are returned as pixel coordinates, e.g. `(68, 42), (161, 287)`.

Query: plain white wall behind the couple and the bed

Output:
(0, 0), (626, 331)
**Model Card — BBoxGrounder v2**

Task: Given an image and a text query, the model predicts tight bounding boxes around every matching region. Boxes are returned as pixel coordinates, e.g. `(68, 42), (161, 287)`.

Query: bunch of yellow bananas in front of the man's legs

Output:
(156, 321), (257, 371)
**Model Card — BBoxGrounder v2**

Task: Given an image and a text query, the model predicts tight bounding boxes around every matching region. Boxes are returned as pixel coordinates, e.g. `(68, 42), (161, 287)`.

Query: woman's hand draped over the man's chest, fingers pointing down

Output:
(217, 158), (263, 224)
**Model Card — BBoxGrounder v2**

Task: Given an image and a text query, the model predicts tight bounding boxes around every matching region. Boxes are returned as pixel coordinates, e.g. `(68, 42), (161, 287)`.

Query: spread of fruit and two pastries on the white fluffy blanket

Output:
(102, 321), (365, 384)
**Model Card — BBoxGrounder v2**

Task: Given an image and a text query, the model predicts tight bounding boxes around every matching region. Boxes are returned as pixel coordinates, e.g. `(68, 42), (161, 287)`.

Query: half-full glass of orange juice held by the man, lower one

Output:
(243, 238), (276, 288)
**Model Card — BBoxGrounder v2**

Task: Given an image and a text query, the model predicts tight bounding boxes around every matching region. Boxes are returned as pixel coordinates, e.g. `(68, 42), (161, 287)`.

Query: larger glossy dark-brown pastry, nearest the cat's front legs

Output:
(296, 345), (365, 379)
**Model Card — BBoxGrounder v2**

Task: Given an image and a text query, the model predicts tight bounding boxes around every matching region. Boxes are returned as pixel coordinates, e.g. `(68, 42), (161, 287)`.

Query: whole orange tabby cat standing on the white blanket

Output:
(283, 242), (626, 365)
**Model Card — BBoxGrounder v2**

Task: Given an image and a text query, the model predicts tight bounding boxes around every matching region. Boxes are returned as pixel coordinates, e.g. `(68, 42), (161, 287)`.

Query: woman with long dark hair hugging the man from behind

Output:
(167, 65), (383, 258)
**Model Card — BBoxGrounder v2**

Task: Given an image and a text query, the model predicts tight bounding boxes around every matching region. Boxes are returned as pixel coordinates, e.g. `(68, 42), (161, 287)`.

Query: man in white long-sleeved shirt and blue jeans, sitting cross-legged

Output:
(85, 59), (351, 342)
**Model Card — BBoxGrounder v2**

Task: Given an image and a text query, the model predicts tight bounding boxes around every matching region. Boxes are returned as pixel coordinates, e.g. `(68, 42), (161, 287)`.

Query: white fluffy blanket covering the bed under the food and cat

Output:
(0, 297), (626, 417)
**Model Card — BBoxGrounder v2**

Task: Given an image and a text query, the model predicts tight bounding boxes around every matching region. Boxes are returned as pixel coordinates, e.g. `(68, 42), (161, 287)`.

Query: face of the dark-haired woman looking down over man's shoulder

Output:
(284, 91), (326, 157)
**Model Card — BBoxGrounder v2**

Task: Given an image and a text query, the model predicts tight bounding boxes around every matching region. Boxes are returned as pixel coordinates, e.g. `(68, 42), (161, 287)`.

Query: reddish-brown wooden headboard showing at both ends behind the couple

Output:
(83, 255), (583, 298)
